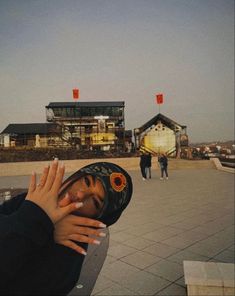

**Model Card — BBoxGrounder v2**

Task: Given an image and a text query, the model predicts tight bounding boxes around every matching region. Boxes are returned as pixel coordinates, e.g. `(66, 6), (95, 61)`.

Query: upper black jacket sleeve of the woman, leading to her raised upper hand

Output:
(0, 200), (54, 291)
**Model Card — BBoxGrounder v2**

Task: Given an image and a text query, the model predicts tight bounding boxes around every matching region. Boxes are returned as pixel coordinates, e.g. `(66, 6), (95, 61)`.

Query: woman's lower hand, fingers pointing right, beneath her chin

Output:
(54, 215), (106, 255)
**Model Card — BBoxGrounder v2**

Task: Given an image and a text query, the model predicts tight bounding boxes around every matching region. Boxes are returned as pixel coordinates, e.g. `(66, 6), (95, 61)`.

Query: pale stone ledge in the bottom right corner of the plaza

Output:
(183, 261), (235, 296)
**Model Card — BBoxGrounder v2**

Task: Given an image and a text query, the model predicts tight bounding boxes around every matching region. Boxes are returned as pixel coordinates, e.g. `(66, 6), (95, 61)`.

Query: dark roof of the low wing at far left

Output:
(1, 123), (56, 135)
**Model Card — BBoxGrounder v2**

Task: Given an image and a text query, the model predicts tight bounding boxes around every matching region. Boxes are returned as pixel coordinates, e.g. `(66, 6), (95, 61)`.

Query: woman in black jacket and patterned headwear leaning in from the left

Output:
(0, 160), (132, 295)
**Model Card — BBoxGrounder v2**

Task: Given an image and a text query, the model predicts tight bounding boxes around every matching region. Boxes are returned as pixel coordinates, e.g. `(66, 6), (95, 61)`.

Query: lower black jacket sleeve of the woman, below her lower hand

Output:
(7, 243), (87, 295)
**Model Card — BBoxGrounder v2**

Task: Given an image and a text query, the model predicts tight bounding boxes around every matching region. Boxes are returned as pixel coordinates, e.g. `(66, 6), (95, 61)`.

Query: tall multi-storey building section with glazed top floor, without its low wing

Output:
(46, 101), (125, 151)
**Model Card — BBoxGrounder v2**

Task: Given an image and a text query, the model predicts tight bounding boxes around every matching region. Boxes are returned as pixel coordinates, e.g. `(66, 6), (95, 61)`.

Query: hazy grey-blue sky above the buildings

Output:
(0, 0), (234, 142)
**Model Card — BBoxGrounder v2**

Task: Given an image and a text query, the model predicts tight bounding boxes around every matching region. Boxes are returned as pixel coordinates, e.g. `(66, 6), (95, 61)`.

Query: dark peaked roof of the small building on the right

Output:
(139, 113), (186, 133)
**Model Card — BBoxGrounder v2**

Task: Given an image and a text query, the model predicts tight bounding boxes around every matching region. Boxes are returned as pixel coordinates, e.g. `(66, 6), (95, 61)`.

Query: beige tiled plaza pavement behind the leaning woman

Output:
(0, 163), (234, 296)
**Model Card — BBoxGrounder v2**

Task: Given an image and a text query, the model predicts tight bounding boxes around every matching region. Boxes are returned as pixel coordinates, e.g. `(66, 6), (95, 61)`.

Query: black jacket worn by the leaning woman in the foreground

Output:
(0, 194), (87, 295)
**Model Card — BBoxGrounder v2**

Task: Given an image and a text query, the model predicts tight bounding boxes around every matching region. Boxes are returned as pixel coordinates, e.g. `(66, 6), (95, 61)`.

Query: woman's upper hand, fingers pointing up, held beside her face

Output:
(26, 159), (82, 224)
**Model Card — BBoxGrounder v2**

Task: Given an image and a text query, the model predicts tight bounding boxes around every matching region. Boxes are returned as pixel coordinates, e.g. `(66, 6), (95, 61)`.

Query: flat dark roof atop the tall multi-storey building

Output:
(46, 101), (125, 109)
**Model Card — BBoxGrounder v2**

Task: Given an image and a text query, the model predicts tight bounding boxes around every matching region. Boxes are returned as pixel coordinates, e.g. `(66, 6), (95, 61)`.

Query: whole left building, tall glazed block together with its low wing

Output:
(0, 101), (129, 152)
